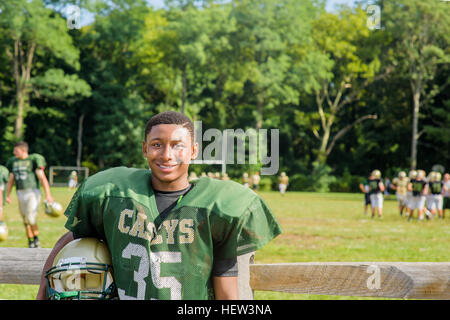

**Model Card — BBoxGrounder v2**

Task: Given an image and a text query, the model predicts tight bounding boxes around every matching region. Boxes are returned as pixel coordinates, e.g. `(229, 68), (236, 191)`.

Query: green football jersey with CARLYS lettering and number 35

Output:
(65, 167), (281, 300)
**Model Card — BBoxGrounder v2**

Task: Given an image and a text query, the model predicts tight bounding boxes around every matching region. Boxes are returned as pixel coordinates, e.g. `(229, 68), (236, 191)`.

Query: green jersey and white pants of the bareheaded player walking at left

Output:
(6, 153), (46, 225)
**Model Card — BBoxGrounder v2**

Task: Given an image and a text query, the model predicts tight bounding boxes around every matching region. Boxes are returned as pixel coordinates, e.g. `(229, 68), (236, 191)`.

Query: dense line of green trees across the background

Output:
(0, 0), (450, 191)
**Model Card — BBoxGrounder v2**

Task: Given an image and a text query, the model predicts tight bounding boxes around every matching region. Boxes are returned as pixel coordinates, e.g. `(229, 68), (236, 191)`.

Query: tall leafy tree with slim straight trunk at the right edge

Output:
(380, 0), (450, 169)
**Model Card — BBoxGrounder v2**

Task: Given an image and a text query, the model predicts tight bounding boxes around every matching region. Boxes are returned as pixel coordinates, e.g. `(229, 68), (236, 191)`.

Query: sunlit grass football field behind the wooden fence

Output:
(0, 188), (450, 300)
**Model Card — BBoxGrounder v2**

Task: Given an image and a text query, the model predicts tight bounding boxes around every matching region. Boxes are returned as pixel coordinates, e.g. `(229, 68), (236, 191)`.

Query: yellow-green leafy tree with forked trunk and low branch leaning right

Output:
(296, 8), (384, 164)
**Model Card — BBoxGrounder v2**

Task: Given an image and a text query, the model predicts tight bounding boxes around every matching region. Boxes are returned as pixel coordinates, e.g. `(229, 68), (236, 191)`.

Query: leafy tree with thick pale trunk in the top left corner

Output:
(0, 0), (79, 139)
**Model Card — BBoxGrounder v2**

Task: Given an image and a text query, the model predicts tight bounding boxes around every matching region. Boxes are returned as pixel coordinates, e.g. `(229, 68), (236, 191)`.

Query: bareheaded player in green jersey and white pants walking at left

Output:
(6, 141), (53, 248)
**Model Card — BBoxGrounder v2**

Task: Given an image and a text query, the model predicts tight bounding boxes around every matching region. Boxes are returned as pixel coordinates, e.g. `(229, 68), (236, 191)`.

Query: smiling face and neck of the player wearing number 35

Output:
(142, 124), (198, 191)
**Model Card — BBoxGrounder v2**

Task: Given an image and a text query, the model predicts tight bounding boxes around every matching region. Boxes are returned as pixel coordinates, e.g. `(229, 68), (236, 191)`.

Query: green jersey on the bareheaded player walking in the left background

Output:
(6, 153), (46, 190)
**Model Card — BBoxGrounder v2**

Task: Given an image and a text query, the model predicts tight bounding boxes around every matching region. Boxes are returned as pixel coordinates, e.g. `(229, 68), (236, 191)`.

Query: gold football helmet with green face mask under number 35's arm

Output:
(45, 238), (117, 300)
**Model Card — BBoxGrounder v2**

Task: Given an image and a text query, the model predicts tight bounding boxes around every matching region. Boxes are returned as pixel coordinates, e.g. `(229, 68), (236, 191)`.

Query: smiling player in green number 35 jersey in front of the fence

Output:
(37, 111), (281, 300)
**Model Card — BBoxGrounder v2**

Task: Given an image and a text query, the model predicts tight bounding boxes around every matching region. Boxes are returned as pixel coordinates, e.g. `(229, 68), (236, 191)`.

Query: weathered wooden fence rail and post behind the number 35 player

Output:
(0, 248), (450, 300)
